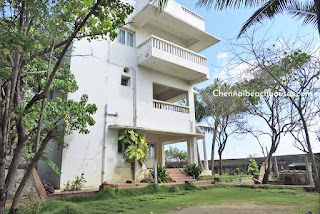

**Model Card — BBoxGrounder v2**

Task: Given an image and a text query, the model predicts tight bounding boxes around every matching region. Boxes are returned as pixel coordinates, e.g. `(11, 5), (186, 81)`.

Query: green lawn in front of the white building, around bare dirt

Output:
(19, 184), (319, 214)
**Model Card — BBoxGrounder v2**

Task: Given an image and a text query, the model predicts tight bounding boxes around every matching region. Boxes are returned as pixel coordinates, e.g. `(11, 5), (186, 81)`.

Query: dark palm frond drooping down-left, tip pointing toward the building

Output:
(238, 0), (295, 38)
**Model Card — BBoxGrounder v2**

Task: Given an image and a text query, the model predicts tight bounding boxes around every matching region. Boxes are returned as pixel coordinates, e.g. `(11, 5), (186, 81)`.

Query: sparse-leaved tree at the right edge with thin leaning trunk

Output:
(226, 30), (320, 189)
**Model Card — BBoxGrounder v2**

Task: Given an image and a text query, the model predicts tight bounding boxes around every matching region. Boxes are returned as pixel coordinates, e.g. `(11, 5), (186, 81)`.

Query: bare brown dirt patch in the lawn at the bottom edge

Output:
(172, 202), (294, 214)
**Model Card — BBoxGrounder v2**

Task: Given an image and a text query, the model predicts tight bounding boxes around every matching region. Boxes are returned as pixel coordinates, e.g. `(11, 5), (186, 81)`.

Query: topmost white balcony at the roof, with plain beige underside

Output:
(130, 0), (219, 52)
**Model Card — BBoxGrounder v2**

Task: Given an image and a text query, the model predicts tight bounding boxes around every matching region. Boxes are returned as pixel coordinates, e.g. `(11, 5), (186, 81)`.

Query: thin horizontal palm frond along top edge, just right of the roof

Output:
(196, 0), (266, 10)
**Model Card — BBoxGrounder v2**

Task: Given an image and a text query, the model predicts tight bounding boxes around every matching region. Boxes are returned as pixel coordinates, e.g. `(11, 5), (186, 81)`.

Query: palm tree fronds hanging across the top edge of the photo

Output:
(158, 0), (320, 38)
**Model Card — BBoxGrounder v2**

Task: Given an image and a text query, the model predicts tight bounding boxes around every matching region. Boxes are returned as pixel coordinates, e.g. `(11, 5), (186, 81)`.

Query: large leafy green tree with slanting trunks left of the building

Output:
(0, 0), (133, 214)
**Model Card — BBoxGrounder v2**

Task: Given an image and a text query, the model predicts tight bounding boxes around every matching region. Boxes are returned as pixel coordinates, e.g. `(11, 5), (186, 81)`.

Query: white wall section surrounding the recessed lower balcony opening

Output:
(137, 68), (194, 133)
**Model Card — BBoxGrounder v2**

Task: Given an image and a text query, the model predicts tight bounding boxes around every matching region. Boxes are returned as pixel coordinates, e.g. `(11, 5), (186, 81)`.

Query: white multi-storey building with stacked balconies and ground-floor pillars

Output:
(38, 0), (219, 188)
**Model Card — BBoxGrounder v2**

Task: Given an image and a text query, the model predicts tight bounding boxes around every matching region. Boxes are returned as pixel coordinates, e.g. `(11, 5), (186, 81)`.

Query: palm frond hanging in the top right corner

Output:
(287, 1), (318, 27)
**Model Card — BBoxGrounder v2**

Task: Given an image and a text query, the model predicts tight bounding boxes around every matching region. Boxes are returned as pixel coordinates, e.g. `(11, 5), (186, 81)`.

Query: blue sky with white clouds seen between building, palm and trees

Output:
(166, 0), (320, 159)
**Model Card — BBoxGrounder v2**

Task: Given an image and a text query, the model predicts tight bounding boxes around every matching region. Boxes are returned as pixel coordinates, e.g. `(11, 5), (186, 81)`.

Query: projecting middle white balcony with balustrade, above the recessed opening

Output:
(138, 35), (209, 84)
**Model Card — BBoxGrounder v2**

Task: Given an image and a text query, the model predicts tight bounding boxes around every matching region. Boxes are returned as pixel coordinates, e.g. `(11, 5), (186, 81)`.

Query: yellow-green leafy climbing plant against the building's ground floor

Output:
(118, 129), (148, 166)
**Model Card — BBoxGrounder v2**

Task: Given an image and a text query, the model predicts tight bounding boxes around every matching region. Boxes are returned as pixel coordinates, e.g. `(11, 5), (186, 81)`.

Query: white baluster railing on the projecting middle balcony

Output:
(138, 35), (207, 66)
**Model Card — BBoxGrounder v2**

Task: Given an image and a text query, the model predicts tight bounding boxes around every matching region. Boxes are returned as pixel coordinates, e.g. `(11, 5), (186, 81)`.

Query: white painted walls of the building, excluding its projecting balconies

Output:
(55, 0), (212, 188)
